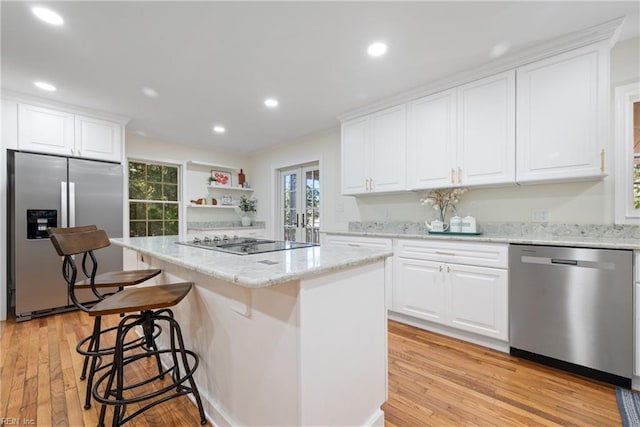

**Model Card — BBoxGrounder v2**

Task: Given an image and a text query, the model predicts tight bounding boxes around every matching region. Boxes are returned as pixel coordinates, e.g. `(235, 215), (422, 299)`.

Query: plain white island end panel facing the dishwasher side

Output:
(299, 260), (387, 426)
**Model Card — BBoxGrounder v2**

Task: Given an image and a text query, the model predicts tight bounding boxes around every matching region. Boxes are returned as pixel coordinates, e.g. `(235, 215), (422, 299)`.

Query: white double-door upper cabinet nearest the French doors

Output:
(342, 105), (406, 194)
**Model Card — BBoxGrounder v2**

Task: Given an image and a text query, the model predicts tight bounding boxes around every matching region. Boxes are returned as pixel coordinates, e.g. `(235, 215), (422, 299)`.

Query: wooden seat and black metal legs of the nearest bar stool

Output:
(89, 283), (207, 426)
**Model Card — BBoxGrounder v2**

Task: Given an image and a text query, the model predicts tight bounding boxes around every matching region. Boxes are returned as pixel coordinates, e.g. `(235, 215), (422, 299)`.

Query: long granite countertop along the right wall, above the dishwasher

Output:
(326, 231), (640, 250)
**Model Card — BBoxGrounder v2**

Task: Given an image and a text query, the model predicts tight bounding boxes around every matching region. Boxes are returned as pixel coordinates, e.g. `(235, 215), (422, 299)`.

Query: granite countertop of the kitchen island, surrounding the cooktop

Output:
(111, 236), (393, 288)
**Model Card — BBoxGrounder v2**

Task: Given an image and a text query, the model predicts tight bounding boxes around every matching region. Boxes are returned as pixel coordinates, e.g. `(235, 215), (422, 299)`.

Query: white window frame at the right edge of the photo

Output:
(614, 81), (640, 224)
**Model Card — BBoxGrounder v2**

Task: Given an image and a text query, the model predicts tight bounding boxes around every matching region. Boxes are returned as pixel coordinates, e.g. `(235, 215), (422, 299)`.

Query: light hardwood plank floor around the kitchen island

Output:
(0, 312), (620, 427)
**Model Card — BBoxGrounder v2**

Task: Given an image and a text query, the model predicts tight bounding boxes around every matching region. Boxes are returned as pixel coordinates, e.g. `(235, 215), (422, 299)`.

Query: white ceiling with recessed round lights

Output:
(0, 1), (640, 152)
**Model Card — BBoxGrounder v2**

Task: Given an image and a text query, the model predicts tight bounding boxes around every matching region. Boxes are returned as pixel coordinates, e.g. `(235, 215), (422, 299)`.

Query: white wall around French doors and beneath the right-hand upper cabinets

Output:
(250, 38), (640, 231)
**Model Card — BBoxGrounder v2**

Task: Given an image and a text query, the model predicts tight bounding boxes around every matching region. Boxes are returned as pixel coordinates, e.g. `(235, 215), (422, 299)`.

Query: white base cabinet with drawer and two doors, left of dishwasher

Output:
(392, 240), (509, 342)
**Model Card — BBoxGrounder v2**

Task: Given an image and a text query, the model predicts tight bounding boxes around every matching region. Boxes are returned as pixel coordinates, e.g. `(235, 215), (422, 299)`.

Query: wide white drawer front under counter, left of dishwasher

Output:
(394, 239), (509, 268)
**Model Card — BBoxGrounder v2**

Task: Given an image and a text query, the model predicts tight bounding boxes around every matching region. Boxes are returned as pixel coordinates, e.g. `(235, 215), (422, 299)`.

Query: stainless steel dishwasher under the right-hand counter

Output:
(509, 245), (633, 387)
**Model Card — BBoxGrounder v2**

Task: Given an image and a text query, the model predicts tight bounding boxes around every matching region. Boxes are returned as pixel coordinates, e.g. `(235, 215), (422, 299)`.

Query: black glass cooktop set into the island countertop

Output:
(177, 237), (318, 255)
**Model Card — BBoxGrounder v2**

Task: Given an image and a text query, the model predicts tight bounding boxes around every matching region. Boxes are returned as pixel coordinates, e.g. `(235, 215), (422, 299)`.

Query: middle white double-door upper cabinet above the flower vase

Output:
(407, 70), (515, 189)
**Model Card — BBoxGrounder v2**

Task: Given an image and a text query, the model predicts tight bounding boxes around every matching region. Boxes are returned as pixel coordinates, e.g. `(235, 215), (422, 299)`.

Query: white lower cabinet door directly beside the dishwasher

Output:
(446, 264), (509, 341)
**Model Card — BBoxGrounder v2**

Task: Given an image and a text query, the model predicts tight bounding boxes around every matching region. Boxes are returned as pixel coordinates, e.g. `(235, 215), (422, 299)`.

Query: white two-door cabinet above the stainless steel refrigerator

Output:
(18, 103), (123, 162)
